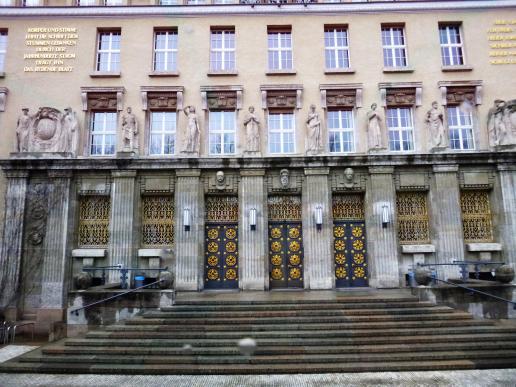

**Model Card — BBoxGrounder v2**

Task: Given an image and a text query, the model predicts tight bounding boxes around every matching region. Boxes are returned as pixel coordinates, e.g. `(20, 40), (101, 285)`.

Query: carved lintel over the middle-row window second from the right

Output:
(378, 82), (423, 107)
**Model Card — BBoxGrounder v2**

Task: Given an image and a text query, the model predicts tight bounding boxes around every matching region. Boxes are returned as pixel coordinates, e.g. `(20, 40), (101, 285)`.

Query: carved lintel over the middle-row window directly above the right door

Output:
(319, 83), (362, 109)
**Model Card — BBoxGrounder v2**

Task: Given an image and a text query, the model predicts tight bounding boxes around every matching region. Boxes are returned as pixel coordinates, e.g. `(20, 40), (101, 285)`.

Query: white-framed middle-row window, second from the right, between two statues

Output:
(387, 107), (414, 151)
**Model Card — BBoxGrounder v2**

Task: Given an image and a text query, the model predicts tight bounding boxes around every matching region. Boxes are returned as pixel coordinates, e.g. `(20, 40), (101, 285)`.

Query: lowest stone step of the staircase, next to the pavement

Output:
(0, 358), (516, 375)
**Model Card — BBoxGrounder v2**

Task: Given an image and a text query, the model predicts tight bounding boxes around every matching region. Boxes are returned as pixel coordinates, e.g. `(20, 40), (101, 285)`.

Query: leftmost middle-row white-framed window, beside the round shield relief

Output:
(90, 112), (116, 156)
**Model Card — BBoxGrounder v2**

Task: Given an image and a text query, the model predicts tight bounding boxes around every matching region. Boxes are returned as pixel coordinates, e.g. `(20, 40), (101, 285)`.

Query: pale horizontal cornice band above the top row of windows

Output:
(0, 0), (516, 17)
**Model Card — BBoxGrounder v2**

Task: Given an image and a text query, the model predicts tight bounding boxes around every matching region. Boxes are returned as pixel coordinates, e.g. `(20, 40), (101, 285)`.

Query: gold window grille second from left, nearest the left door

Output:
(142, 195), (174, 247)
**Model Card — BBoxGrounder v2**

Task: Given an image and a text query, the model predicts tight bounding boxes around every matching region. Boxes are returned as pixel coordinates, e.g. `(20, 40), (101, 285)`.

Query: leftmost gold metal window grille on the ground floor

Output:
(79, 195), (111, 247)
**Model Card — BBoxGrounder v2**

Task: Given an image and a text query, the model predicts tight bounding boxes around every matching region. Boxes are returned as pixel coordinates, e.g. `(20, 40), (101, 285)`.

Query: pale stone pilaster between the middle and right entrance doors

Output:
(303, 168), (335, 289)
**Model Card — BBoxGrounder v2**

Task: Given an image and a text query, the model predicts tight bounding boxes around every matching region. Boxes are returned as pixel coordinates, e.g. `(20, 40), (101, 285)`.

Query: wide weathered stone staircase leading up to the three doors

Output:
(0, 291), (516, 374)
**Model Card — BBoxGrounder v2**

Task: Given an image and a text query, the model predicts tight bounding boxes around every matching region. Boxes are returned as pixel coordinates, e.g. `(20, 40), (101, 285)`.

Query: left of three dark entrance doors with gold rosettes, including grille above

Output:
(204, 196), (238, 289)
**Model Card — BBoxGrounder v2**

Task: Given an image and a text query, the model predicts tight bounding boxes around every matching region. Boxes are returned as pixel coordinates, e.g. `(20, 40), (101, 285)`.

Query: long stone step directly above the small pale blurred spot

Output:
(86, 326), (516, 340)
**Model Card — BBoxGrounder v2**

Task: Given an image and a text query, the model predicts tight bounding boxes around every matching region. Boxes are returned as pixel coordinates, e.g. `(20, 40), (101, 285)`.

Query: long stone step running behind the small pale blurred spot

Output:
(41, 340), (516, 356)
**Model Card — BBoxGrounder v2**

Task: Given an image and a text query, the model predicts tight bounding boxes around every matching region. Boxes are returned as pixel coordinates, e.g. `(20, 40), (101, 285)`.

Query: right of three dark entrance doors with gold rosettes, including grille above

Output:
(333, 194), (368, 288)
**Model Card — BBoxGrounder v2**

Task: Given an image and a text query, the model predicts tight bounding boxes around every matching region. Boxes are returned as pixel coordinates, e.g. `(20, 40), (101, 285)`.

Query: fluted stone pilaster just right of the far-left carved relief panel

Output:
(41, 170), (72, 309)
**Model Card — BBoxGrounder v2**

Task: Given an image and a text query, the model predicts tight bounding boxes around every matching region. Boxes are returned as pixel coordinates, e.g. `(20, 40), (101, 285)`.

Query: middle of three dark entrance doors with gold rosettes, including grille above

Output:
(268, 195), (303, 289)
